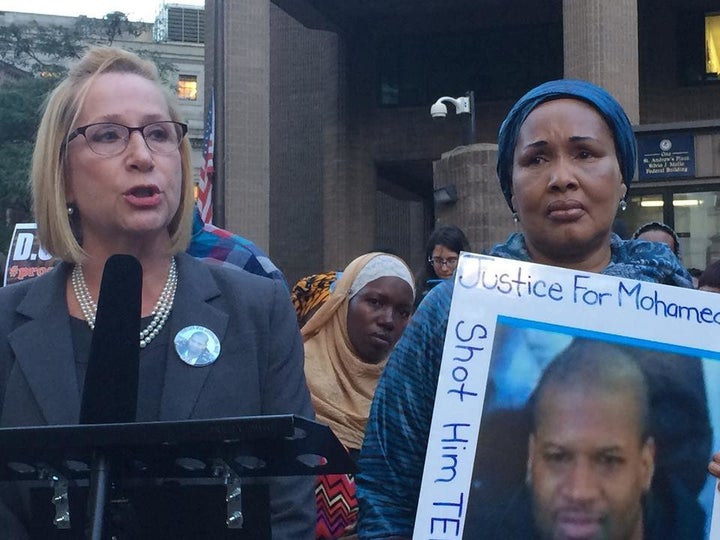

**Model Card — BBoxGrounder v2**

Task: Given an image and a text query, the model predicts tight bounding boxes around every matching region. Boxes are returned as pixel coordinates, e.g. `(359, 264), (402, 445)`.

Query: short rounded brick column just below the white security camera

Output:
(433, 143), (516, 252)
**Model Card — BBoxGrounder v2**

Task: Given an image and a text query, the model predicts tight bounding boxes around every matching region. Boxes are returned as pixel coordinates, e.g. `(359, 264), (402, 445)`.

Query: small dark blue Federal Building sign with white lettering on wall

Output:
(637, 134), (695, 180)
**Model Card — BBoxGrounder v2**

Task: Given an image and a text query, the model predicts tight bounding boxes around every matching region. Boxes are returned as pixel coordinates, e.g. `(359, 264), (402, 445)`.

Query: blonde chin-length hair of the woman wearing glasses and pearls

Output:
(30, 47), (195, 263)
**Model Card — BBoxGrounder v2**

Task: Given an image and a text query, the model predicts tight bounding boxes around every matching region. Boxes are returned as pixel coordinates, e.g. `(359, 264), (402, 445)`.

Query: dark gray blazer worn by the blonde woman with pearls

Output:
(0, 254), (315, 539)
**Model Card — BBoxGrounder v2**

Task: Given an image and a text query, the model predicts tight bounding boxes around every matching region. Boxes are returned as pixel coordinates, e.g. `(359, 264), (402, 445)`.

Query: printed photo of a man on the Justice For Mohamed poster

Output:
(464, 321), (717, 540)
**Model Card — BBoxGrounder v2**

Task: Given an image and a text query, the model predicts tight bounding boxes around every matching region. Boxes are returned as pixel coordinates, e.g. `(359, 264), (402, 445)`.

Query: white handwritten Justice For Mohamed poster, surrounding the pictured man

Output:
(414, 253), (720, 540)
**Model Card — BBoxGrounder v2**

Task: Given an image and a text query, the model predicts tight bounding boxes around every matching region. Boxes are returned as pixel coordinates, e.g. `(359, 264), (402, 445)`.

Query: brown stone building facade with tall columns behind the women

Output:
(206, 0), (720, 279)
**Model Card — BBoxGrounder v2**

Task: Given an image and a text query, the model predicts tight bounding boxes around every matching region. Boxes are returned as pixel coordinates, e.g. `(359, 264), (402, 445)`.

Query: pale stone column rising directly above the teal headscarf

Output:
(563, 0), (640, 124)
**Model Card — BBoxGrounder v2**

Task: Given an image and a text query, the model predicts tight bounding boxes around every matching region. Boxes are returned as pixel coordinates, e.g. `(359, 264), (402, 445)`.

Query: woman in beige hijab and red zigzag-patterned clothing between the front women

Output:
(302, 252), (415, 539)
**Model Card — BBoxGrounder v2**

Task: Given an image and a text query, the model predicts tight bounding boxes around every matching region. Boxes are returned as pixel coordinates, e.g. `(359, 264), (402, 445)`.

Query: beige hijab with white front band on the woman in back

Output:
(302, 253), (415, 449)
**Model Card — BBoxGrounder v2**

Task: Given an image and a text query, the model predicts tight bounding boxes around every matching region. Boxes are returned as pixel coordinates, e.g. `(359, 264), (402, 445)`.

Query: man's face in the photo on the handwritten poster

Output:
(528, 386), (654, 540)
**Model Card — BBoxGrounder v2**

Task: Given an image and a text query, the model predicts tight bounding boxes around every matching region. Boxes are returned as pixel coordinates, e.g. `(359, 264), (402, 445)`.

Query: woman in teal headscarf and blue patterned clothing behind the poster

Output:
(357, 80), (705, 539)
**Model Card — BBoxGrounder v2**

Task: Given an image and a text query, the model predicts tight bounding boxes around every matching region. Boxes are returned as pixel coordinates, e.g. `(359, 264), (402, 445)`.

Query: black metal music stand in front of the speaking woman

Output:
(0, 415), (355, 540)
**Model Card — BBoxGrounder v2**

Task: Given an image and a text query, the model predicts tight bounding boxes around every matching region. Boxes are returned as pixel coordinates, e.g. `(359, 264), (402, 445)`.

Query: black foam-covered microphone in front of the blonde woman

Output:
(80, 255), (142, 424)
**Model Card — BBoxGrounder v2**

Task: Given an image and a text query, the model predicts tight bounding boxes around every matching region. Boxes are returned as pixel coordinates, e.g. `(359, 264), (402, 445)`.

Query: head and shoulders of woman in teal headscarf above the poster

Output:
(490, 79), (692, 287)
